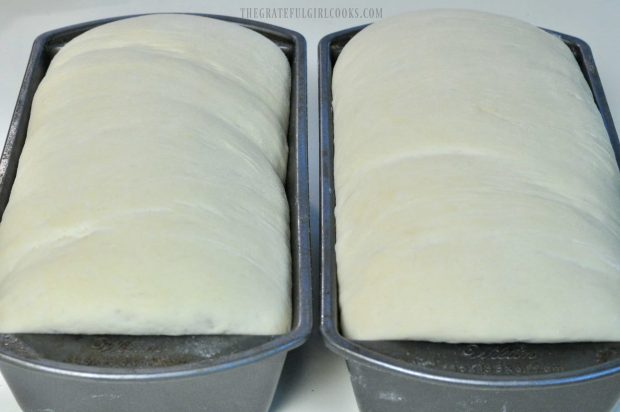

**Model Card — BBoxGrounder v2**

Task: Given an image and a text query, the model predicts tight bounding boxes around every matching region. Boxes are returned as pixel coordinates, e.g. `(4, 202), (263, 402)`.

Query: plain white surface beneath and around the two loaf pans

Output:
(0, 0), (620, 412)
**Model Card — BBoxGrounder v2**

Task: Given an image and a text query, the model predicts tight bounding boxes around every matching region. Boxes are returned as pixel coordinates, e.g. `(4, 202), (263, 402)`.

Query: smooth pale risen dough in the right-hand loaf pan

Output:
(332, 11), (620, 343)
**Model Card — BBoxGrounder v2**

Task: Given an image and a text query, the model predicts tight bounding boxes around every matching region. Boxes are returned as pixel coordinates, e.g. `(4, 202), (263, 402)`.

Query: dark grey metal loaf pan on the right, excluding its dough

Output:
(319, 26), (620, 412)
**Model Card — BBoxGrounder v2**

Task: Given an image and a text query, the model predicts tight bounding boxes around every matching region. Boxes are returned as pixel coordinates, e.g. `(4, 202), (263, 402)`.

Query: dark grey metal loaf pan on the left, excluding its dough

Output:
(0, 14), (312, 412)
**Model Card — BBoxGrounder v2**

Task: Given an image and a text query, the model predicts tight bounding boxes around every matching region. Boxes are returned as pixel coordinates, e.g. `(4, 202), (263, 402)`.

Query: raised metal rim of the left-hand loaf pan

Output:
(0, 12), (312, 381)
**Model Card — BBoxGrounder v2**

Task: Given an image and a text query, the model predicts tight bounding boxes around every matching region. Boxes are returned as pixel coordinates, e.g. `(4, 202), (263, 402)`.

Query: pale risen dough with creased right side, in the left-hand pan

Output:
(0, 15), (291, 335)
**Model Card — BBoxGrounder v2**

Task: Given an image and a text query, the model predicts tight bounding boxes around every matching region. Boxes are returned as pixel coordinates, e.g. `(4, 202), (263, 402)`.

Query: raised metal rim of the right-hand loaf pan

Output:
(318, 24), (620, 389)
